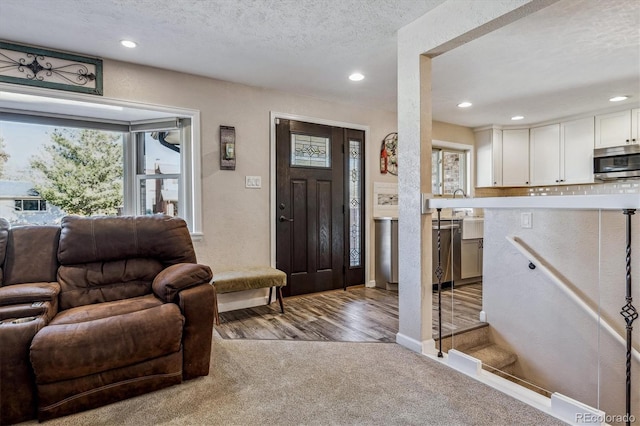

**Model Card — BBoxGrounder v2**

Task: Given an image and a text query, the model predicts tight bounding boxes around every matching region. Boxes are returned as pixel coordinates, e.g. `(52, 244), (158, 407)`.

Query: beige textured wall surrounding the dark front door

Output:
(104, 60), (396, 310)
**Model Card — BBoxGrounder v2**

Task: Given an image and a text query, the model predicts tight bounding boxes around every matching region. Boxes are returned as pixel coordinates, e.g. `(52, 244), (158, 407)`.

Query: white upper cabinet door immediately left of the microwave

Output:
(560, 117), (595, 183)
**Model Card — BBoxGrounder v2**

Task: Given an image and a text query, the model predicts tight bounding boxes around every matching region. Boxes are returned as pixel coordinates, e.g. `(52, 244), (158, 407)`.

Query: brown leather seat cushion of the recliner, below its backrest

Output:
(51, 294), (163, 325)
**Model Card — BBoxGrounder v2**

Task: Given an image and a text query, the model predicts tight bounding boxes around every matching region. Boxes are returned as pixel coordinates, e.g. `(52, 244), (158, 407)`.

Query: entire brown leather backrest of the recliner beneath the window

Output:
(58, 215), (196, 310)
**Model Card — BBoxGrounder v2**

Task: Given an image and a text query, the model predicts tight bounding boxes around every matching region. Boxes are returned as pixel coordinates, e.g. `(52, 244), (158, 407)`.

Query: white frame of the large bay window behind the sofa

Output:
(0, 83), (203, 236)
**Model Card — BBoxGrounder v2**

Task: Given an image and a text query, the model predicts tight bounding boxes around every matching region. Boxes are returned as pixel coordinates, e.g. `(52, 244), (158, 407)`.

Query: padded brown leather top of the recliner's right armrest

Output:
(151, 263), (213, 302)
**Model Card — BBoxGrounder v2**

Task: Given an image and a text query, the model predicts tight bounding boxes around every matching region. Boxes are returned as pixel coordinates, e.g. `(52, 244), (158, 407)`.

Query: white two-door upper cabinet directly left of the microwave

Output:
(529, 117), (594, 185)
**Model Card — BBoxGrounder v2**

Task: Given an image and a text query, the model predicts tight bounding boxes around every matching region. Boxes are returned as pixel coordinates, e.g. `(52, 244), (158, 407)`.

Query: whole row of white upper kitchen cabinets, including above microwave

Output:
(476, 108), (640, 187)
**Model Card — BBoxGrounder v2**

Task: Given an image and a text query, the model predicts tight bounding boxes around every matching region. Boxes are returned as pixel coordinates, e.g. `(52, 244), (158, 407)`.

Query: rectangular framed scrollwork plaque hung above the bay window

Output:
(0, 42), (102, 95)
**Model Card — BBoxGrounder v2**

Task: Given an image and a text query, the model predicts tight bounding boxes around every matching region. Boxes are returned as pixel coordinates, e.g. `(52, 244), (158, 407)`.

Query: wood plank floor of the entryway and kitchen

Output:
(214, 285), (482, 342)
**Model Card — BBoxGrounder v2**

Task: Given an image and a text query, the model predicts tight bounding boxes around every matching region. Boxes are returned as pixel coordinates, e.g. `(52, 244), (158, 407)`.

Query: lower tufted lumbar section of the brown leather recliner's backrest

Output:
(58, 258), (163, 310)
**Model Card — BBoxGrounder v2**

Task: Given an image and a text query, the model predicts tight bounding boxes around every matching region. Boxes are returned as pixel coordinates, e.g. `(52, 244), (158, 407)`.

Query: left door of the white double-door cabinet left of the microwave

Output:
(529, 124), (561, 185)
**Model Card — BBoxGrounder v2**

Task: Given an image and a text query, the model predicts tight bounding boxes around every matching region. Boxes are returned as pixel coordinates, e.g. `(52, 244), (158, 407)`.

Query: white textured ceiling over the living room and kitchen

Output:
(0, 0), (640, 127)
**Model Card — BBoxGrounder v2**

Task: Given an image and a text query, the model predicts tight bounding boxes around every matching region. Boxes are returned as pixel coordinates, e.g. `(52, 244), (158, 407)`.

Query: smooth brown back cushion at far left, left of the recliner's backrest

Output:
(0, 225), (60, 286)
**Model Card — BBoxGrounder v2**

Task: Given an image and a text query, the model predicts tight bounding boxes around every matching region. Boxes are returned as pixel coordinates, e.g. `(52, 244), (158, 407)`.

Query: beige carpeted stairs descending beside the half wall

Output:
(435, 322), (551, 397)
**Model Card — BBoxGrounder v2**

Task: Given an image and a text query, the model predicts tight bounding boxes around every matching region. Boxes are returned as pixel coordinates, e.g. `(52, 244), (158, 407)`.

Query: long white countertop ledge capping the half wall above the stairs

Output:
(422, 194), (640, 213)
